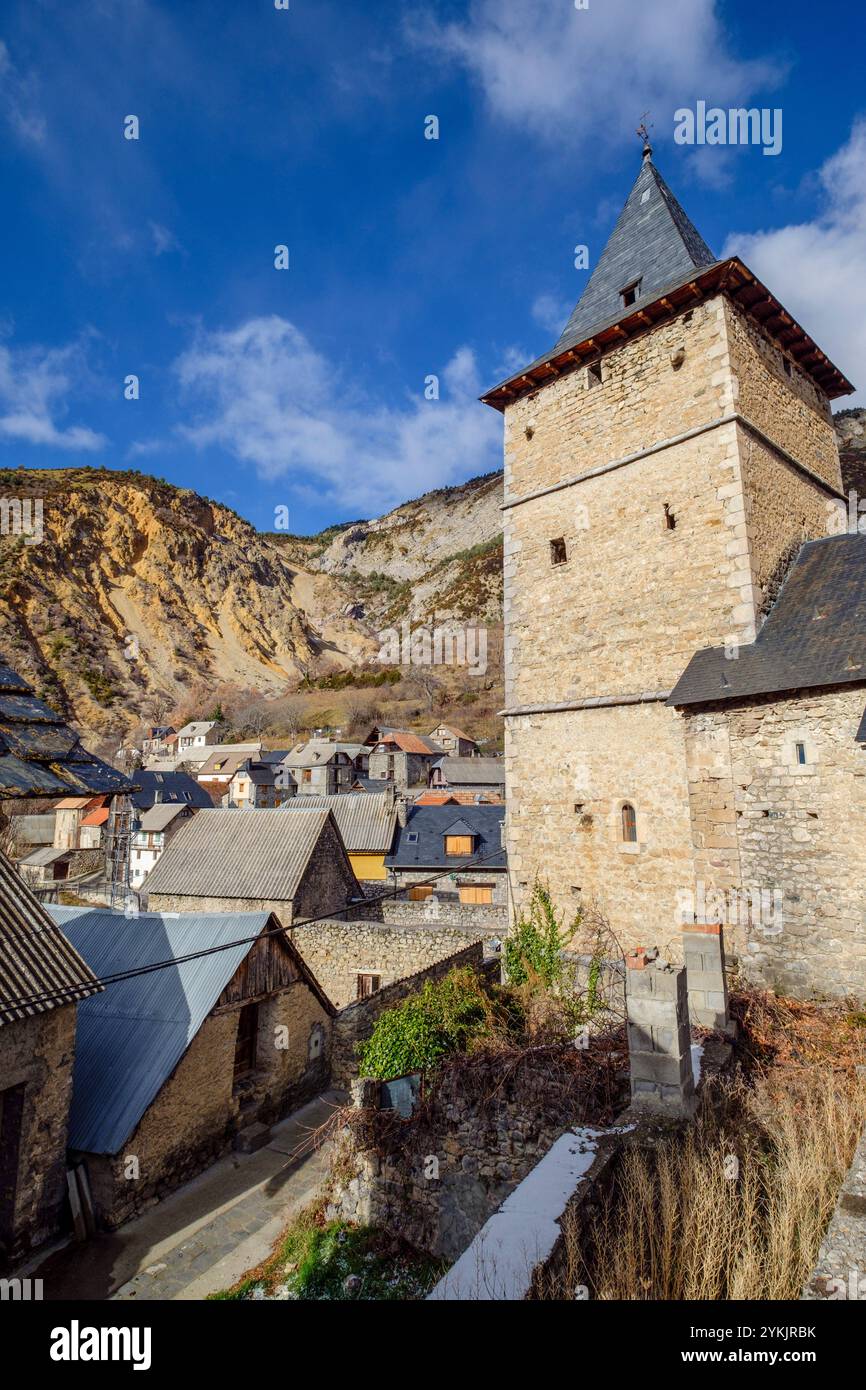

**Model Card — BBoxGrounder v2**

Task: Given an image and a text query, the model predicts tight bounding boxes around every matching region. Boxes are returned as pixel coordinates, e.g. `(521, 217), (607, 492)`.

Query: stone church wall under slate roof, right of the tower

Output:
(684, 685), (866, 998)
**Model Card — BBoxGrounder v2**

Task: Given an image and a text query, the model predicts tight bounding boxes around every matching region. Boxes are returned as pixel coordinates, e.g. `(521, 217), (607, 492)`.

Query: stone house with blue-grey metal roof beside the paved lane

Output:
(51, 906), (335, 1229)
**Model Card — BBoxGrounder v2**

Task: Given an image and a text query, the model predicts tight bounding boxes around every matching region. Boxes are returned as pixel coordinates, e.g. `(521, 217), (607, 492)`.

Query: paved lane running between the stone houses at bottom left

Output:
(31, 1091), (345, 1302)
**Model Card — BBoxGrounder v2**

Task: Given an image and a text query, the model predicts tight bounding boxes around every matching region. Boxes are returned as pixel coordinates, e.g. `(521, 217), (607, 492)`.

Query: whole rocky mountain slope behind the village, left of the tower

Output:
(0, 468), (500, 735)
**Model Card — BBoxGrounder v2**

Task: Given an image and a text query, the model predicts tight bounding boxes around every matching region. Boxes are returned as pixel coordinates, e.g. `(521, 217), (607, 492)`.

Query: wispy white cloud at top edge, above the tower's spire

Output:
(409, 0), (778, 157)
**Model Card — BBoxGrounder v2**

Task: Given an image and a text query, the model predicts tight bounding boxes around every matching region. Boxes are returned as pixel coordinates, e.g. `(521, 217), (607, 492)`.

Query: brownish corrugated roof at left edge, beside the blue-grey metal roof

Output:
(0, 853), (101, 1026)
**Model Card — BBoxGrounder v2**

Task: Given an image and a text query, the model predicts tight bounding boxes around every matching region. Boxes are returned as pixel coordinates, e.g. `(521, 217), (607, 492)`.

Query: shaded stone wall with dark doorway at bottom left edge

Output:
(0, 1004), (75, 1268)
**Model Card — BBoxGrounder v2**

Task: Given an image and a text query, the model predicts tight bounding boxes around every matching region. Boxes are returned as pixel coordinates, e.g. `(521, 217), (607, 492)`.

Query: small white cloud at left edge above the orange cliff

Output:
(0, 343), (106, 453)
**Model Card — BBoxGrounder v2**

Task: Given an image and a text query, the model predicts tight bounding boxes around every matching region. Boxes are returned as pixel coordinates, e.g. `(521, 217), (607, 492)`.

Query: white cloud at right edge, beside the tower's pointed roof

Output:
(723, 120), (866, 407)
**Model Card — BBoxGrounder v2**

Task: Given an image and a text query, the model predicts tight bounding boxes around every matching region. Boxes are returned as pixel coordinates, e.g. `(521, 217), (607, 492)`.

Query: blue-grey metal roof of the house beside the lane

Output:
(49, 905), (270, 1154)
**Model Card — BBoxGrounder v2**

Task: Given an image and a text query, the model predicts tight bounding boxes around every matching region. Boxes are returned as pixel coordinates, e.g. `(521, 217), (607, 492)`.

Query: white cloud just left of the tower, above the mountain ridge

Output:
(175, 316), (502, 512)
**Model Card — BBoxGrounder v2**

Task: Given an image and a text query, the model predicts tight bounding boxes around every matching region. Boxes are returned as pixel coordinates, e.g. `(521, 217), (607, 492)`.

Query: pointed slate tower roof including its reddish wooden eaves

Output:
(481, 154), (853, 410)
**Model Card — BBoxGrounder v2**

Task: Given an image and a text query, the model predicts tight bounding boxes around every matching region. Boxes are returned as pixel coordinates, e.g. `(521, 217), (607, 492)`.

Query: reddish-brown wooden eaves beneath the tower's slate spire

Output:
(481, 256), (855, 410)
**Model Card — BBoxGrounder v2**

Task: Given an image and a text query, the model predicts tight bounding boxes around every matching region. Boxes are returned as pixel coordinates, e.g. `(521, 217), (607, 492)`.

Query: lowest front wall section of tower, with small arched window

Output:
(506, 703), (692, 959)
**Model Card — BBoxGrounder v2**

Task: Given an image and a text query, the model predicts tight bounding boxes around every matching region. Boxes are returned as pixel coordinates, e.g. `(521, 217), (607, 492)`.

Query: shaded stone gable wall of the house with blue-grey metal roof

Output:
(88, 981), (329, 1229)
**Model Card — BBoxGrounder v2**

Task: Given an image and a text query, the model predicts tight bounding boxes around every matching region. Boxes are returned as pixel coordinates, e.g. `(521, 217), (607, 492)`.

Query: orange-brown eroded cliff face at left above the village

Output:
(0, 468), (378, 733)
